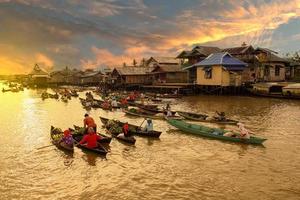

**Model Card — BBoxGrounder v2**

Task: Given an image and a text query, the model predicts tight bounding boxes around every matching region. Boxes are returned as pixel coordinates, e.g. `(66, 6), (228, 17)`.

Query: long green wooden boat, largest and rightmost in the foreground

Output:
(167, 119), (267, 144)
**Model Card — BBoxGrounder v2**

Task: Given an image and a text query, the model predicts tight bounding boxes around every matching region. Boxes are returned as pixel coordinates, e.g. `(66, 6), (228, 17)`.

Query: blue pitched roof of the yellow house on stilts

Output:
(185, 52), (247, 71)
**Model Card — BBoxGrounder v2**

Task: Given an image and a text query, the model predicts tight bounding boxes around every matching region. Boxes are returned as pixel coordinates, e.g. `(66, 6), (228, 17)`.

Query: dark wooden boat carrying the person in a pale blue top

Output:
(100, 117), (161, 138)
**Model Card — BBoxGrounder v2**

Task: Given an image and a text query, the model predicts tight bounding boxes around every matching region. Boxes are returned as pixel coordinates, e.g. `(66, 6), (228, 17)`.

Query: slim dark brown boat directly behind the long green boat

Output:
(177, 111), (238, 124)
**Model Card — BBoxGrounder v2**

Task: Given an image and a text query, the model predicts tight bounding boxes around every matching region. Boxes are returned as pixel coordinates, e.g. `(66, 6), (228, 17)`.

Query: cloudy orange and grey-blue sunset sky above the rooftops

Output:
(0, 0), (300, 74)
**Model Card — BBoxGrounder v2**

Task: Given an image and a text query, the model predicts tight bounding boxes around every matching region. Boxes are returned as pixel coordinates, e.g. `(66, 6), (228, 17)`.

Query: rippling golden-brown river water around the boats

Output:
(0, 81), (300, 200)
